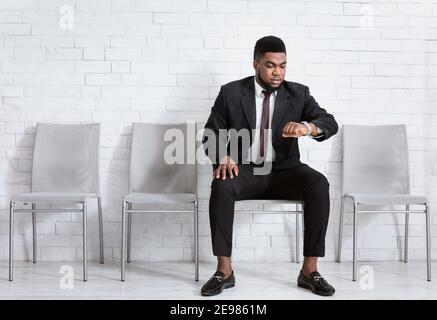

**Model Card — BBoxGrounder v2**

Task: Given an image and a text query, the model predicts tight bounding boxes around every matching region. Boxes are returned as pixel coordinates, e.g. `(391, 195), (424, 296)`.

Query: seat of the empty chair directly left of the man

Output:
(124, 193), (197, 204)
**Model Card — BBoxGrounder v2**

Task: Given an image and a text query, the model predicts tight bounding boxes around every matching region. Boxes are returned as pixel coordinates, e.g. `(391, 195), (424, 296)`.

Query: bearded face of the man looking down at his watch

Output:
(253, 52), (287, 89)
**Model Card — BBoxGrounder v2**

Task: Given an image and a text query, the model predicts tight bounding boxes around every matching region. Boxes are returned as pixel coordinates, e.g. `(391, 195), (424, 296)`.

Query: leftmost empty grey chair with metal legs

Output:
(9, 123), (104, 281)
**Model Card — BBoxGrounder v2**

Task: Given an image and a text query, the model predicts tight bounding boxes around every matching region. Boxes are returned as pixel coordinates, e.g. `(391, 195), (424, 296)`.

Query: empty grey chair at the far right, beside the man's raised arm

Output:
(337, 125), (431, 281)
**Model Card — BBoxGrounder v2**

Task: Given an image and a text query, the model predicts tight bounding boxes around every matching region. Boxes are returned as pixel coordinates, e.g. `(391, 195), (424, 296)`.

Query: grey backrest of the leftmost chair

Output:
(32, 123), (100, 194)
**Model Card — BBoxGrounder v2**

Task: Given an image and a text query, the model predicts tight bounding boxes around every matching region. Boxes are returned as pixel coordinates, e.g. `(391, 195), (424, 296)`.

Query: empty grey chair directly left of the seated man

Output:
(121, 123), (199, 281)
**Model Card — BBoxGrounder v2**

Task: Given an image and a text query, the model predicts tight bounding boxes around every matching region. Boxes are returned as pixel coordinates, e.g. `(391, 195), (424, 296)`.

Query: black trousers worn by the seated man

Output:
(209, 164), (330, 257)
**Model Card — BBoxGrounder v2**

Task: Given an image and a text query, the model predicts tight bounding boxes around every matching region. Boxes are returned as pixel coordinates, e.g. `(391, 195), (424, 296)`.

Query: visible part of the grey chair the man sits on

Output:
(235, 199), (304, 263)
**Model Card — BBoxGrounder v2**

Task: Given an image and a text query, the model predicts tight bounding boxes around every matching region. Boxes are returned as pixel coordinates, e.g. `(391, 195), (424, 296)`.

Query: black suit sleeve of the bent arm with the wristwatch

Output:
(302, 87), (338, 142)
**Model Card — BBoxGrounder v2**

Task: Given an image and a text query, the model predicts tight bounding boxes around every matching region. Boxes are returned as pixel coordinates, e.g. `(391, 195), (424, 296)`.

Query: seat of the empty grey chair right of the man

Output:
(346, 193), (428, 205)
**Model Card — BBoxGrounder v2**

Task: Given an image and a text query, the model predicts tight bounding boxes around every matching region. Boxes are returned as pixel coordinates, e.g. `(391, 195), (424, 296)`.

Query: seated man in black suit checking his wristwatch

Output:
(201, 36), (338, 296)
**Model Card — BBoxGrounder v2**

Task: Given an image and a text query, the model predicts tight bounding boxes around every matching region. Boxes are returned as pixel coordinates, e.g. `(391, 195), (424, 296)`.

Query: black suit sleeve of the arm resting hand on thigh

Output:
(202, 87), (228, 169)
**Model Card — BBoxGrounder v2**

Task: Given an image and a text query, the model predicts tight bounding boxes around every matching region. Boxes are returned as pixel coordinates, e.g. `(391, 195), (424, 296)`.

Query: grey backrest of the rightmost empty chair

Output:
(343, 125), (410, 194)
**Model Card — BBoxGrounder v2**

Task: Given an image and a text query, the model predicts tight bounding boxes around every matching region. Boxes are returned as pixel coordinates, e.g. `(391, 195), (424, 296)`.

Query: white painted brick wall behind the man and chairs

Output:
(0, 0), (437, 261)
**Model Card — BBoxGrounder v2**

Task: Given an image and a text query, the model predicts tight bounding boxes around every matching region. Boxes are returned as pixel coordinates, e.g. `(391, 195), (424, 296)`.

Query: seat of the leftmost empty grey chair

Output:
(11, 192), (97, 203)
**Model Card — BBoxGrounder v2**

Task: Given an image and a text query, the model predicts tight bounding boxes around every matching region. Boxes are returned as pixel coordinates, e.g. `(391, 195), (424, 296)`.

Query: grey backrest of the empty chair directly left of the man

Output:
(129, 123), (197, 194)
